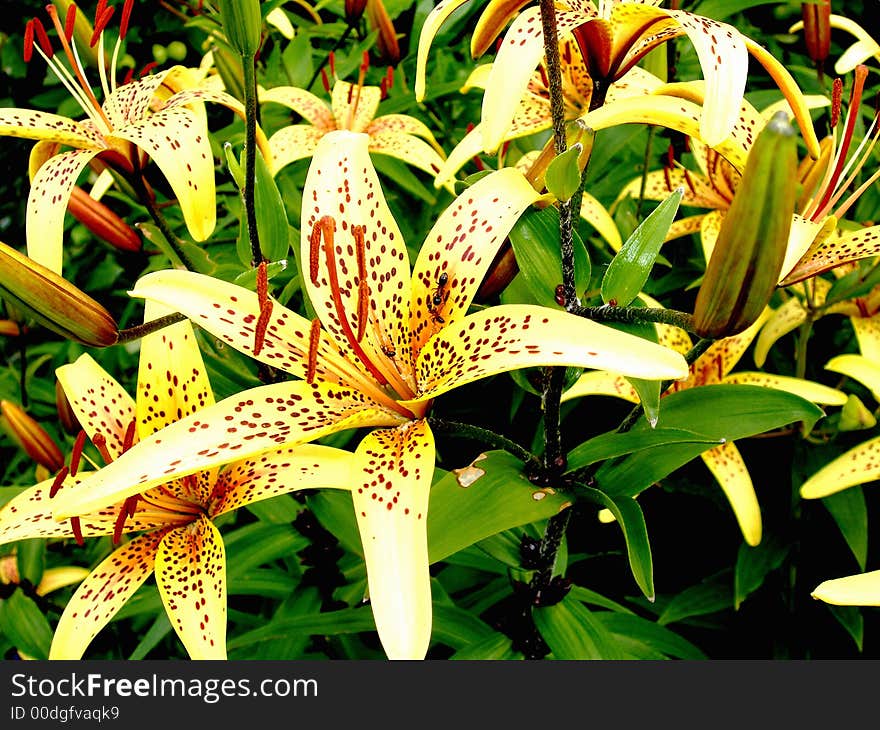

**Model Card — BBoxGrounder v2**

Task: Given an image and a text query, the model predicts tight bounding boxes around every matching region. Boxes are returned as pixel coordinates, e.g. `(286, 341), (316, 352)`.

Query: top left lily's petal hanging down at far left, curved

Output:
(26, 147), (101, 274)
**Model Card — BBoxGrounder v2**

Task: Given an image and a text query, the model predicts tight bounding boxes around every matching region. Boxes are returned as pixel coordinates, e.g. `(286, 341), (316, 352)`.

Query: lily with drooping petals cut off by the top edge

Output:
(415, 0), (820, 152)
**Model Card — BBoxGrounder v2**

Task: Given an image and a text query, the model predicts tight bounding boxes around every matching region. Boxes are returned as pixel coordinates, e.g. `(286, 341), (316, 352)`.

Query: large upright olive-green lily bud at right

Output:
(694, 112), (797, 339)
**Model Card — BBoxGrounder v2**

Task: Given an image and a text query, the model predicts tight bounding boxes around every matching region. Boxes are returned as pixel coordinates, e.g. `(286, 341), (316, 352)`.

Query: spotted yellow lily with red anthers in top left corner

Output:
(0, 0), (262, 273)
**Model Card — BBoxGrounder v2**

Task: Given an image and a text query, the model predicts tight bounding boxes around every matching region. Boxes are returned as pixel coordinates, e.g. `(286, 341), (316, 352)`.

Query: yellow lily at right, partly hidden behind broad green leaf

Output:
(562, 310), (846, 546)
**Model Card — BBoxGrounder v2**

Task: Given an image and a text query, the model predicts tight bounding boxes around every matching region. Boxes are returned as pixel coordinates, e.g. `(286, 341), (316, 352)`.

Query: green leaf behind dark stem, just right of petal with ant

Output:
(510, 206), (590, 309)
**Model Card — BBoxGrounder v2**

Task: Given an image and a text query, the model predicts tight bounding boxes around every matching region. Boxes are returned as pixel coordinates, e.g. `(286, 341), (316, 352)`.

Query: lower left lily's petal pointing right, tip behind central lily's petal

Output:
(209, 444), (352, 519)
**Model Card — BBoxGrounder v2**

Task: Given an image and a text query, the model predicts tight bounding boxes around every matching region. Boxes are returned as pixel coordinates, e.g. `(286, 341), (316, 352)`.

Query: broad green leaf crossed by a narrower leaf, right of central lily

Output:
(595, 385), (823, 496)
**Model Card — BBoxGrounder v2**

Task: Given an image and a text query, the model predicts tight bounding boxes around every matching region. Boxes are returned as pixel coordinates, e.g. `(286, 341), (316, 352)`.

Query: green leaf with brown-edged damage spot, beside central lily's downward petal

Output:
(428, 451), (569, 563)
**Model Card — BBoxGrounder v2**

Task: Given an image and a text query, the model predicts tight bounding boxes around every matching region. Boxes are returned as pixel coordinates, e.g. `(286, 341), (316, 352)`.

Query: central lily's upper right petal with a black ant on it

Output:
(408, 168), (540, 354)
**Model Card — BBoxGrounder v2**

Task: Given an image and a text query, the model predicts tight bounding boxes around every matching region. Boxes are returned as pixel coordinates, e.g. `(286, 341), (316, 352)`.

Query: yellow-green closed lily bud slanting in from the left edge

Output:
(0, 242), (119, 347)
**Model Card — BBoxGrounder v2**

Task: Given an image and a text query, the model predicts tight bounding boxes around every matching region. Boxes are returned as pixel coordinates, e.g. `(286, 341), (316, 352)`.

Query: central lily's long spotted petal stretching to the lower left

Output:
(54, 381), (404, 519)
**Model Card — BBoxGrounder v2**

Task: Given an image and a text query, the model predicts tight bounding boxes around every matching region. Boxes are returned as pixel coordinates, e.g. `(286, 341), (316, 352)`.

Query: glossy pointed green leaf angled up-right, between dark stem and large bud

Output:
(601, 188), (684, 307)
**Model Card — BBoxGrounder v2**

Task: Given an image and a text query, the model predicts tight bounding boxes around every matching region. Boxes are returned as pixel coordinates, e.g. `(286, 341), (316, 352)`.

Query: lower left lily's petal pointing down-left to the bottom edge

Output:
(49, 531), (164, 659)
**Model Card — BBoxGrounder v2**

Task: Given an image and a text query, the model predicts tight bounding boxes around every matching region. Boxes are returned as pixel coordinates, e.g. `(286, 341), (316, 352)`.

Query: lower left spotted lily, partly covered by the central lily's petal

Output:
(0, 304), (351, 659)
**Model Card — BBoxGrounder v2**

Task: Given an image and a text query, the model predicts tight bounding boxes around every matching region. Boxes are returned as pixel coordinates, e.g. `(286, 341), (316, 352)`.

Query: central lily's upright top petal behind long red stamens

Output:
(300, 131), (409, 384)
